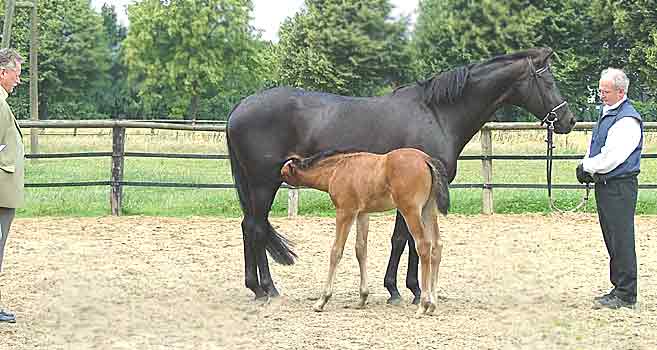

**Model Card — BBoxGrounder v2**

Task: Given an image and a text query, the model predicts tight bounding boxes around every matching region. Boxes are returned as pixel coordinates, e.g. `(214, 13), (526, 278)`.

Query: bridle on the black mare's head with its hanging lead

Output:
(527, 57), (591, 214)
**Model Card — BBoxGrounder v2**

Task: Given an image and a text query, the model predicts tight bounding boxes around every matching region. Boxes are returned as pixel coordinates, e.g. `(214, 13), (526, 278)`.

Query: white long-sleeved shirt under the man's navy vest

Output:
(582, 96), (641, 174)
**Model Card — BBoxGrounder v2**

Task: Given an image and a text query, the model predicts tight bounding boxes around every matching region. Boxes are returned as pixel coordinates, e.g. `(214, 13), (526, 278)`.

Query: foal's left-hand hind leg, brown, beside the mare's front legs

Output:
(403, 208), (435, 316)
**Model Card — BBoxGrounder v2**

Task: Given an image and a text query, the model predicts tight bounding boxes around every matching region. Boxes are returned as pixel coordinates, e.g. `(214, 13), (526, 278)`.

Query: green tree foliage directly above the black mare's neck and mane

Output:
(414, 0), (547, 73)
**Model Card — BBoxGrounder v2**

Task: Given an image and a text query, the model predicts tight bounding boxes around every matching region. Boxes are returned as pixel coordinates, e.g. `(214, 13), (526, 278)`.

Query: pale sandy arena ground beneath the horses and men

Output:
(0, 214), (657, 350)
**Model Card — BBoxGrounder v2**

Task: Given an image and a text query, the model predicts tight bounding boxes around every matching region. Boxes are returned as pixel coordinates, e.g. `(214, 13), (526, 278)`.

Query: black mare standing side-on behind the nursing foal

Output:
(226, 48), (575, 302)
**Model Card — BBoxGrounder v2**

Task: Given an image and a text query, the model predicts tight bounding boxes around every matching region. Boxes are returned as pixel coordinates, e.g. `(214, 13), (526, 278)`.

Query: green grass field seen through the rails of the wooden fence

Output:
(18, 130), (657, 217)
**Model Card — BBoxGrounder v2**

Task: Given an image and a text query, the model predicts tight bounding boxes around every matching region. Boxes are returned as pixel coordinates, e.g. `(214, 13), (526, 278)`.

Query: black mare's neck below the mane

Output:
(451, 63), (518, 153)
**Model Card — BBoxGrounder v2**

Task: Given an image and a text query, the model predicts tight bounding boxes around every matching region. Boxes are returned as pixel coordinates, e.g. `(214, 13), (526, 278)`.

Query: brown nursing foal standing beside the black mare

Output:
(281, 148), (449, 315)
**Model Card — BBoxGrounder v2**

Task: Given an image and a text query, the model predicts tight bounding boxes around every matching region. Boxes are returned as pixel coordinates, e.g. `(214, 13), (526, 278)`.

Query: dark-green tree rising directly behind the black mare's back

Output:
(278, 0), (410, 95)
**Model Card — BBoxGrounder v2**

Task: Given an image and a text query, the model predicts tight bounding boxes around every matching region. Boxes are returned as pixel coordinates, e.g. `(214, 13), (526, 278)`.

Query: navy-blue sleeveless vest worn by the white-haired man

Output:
(589, 100), (643, 179)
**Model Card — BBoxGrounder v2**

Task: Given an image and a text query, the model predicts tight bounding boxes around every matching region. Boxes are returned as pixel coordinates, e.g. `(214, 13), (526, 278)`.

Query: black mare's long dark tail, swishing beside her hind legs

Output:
(226, 102), (297, 265)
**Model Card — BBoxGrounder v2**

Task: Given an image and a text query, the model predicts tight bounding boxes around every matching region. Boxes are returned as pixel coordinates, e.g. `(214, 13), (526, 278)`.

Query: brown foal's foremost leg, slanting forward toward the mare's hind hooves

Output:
(313, 209), (356, 312)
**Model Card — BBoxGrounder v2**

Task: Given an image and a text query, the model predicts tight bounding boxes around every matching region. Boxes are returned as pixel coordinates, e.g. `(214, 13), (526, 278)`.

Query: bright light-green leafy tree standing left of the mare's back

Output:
(124, 0), (252, 118)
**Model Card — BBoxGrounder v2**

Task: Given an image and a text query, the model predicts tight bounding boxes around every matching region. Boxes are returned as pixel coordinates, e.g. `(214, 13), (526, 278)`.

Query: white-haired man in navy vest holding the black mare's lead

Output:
(577, 68), (643, 309)
